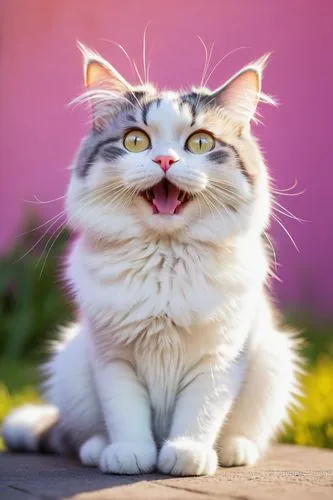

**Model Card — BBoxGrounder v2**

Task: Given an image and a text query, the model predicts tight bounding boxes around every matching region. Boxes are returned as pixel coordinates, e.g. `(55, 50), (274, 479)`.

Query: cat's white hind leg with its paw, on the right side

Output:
(217, 329), (297, 467)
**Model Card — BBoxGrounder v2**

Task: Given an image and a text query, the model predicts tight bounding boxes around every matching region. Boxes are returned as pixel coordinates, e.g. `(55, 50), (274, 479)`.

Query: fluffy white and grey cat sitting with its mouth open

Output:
(2, 45), (298, 476)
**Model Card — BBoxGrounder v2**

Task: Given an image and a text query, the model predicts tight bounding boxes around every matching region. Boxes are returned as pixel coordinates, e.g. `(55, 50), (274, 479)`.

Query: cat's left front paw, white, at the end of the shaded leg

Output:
(99, 441), (157, 474)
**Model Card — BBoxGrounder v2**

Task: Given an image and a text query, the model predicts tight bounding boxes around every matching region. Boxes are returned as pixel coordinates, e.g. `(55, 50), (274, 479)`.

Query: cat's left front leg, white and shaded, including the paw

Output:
(95, 359), (157, 474)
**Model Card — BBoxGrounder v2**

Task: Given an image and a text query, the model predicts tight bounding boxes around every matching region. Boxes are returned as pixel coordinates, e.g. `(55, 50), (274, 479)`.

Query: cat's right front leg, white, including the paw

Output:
(158, 361), (239, 476)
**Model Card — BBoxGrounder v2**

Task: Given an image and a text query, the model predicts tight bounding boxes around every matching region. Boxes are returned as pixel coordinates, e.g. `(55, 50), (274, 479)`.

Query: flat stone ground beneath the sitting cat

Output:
(0, 445), (333, 500)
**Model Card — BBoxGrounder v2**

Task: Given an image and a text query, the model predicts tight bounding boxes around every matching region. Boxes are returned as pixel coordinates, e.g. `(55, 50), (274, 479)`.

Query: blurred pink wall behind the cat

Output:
(0, 0), (333, 312)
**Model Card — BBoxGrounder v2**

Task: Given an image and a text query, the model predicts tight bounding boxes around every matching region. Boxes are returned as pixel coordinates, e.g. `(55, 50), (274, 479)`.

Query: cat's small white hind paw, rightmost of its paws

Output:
(219, 436), (259, 467)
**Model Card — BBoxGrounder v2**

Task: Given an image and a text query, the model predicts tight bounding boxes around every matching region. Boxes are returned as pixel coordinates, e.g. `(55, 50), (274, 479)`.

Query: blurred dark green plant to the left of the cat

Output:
(0, 213), (71, 360)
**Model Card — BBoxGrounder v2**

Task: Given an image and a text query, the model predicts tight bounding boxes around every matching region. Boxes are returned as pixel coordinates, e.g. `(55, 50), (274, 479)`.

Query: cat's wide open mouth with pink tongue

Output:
(140, 179), (192, 215)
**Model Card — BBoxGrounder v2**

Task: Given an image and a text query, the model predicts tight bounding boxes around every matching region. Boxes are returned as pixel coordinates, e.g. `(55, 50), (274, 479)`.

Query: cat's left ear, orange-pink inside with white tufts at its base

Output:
(77, 42), (132, 129)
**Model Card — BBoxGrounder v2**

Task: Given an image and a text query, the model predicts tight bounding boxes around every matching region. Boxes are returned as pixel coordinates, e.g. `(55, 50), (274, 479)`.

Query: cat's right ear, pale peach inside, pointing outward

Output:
(213, 54), (270, 123)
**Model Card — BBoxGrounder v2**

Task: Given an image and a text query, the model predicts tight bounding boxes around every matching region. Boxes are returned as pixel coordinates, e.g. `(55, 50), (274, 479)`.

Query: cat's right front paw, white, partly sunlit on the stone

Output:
(158, 438), (217, 476)
